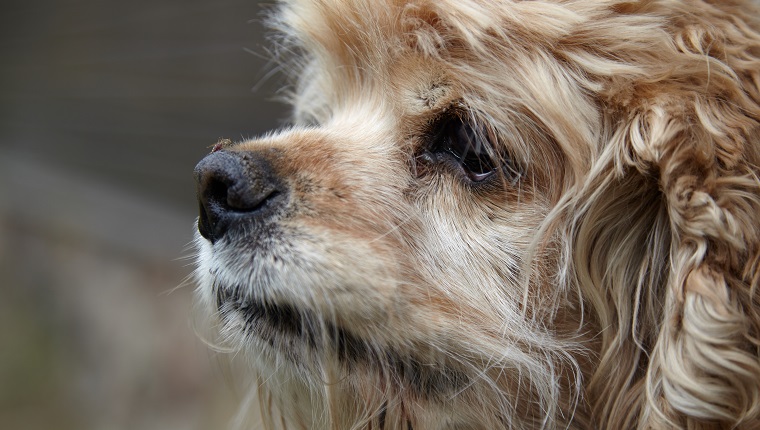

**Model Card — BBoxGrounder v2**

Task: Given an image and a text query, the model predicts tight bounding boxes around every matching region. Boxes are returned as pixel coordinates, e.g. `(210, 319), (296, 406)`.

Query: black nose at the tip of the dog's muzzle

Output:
(195, 151), (287, 243)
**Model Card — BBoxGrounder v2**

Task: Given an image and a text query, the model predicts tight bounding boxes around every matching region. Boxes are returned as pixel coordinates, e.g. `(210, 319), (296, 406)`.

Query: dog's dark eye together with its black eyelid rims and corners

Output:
(417, 108), (519, 183)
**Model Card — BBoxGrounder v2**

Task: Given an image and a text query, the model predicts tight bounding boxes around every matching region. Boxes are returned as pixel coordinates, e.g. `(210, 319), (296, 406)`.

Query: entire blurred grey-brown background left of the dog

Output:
(0, 0), (287, 430)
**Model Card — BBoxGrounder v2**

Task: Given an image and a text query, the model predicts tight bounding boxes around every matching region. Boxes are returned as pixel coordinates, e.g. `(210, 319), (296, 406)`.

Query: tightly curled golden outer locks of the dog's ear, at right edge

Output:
(629, 40), (760, 428)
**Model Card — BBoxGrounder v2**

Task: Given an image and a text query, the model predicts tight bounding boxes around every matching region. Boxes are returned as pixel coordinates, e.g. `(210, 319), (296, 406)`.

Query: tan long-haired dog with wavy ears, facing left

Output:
(195, 0), (760, 430)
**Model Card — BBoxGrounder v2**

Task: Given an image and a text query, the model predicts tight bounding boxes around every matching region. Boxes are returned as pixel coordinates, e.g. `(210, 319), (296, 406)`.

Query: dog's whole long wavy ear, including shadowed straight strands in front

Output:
(566, 1), (760, 429)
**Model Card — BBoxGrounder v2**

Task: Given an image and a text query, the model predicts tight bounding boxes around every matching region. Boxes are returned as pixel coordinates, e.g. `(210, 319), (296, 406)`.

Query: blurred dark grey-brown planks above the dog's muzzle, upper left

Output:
(0, 0), (286, 211)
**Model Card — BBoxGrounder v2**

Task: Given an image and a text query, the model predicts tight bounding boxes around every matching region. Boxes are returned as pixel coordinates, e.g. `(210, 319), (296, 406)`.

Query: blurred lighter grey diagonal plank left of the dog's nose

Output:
(0, 151), (195, 266)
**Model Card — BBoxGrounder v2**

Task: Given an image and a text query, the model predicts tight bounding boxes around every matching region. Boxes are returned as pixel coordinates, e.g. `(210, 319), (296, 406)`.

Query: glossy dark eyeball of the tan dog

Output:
(424, 116), (496, 182)
